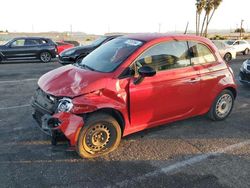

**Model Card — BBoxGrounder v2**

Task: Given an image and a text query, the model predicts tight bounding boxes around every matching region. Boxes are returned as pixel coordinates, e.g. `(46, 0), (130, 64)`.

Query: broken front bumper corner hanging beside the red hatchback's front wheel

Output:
(33, 112), (84, 146)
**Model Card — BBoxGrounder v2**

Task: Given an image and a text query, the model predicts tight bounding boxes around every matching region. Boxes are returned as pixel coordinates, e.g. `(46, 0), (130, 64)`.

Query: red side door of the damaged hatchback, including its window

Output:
(129, 41), (200, 127)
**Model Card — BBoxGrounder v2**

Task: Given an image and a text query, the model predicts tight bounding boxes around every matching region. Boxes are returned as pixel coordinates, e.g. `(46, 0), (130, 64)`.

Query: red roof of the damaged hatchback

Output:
(123, 33), (207, 42)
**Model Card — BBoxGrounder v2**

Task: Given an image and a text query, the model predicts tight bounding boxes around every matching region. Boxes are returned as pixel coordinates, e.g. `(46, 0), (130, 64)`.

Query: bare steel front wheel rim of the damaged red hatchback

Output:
(84, 124), (111, 153)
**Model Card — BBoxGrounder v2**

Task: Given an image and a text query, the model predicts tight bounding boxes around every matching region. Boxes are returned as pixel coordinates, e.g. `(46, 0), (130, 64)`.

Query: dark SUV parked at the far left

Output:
(0, 37), (57, 63)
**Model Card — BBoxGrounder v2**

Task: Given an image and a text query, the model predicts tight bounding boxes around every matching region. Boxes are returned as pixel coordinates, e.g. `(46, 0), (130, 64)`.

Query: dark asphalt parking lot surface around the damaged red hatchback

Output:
(0, 56), (250, 188)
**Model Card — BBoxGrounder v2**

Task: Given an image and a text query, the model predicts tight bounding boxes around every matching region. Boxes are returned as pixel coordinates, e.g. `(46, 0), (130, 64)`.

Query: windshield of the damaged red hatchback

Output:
(78, 38), (143, 72)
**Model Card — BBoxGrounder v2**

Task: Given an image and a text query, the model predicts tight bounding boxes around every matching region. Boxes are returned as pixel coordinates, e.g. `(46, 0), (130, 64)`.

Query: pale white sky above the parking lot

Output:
(0, 0), (250, 34)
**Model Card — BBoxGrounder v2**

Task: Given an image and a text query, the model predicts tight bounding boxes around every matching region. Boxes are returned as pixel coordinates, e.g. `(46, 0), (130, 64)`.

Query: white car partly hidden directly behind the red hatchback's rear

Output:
(212, 40), (236, 62)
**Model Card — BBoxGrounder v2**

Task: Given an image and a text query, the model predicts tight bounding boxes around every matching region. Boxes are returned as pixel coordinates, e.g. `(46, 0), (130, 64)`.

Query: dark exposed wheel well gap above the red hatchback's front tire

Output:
(85, 108), (125, 134)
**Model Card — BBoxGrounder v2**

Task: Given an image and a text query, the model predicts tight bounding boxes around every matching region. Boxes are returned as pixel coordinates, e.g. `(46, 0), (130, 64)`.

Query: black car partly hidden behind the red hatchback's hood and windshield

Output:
(59, 35), (121, 65)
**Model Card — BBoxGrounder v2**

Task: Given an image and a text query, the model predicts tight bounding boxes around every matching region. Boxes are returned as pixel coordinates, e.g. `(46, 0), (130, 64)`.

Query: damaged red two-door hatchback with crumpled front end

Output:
(32, 34), (236, 158)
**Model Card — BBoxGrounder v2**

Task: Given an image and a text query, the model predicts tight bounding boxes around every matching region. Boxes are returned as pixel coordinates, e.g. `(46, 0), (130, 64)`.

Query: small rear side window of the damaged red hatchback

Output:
(188, 42), (216, 65)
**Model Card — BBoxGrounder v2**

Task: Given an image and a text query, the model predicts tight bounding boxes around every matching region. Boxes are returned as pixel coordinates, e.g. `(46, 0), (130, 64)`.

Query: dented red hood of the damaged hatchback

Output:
(38, 65), (109, 98)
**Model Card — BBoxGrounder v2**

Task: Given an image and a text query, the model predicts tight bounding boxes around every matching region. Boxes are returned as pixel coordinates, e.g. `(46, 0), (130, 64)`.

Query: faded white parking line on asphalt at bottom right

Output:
(111, 140), (250, 187)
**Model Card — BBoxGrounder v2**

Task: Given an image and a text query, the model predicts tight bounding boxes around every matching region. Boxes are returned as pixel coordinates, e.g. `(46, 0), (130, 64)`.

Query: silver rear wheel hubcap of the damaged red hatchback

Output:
(216, 94), (233, 118)
